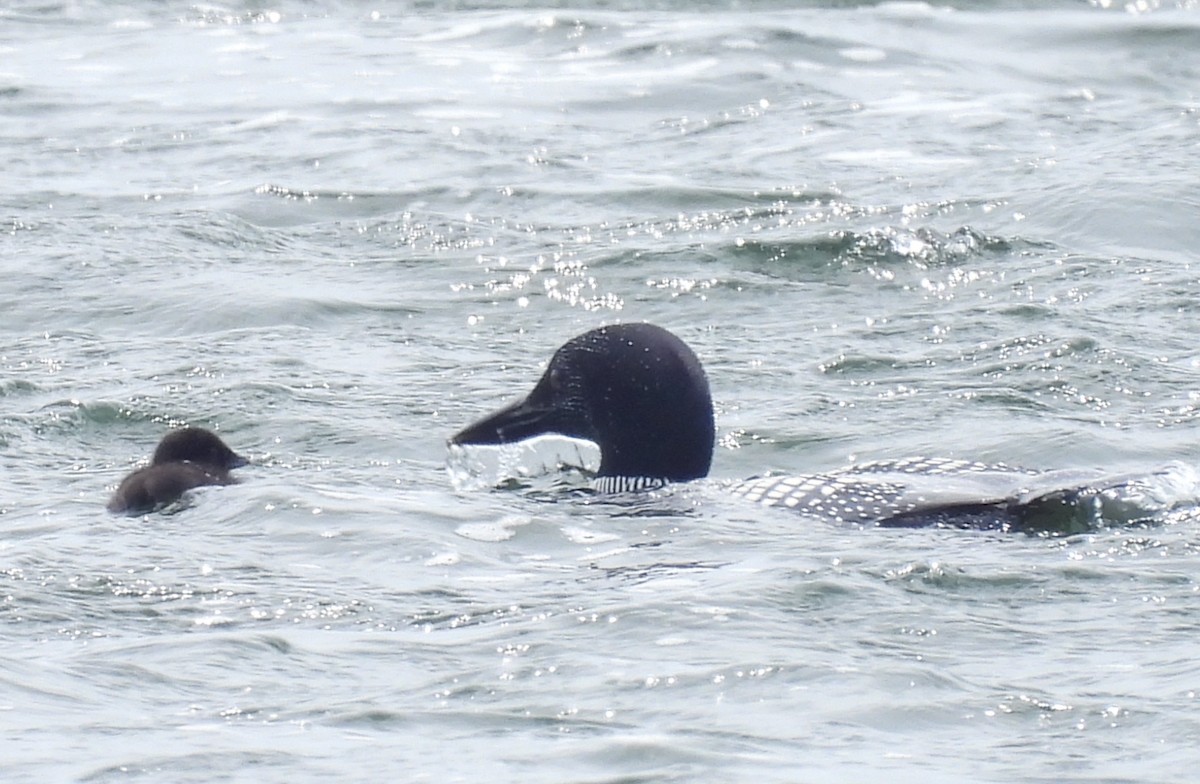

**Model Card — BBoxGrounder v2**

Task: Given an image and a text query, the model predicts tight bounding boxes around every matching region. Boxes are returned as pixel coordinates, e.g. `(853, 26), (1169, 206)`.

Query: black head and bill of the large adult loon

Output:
(450, 324), (714, 481)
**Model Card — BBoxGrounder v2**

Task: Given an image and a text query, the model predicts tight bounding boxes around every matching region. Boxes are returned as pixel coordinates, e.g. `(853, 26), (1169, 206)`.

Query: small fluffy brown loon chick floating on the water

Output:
(108, 427), (250, 515)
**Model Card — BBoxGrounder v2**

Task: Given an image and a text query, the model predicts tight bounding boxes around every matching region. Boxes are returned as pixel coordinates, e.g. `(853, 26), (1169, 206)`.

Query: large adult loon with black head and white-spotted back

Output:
(450, 323), (1185, 531)
